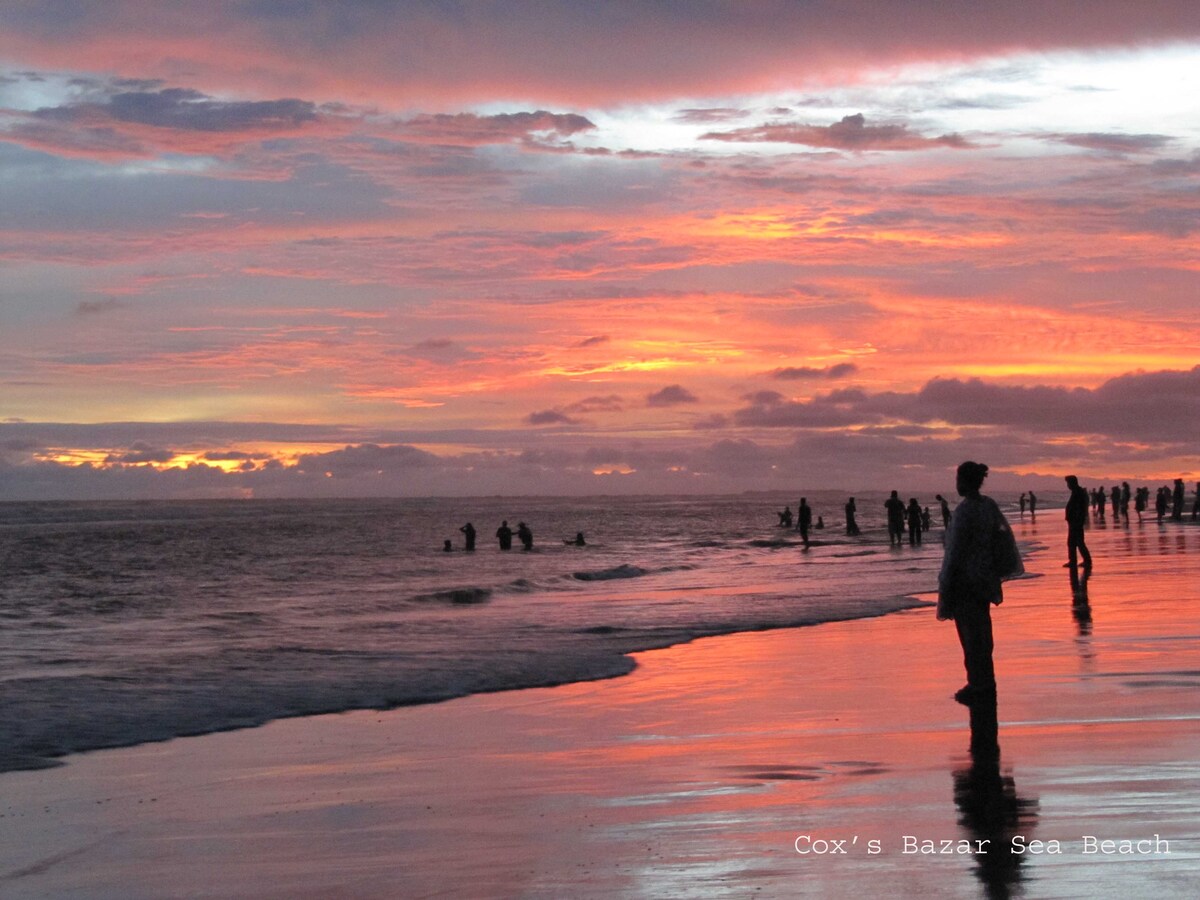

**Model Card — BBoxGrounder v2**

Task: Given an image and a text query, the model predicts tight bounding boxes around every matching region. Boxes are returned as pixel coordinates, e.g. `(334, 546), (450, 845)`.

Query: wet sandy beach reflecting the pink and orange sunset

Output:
(0, 510), (1200, 899)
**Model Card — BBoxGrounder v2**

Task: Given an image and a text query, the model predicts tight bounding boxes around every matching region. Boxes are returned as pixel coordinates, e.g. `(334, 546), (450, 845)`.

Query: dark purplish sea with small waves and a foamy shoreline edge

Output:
(0, 491), (1032, 772)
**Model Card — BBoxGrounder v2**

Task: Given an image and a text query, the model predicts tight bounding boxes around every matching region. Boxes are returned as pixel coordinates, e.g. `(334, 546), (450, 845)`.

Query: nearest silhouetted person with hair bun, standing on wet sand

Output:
(937, 461), (1024, 704)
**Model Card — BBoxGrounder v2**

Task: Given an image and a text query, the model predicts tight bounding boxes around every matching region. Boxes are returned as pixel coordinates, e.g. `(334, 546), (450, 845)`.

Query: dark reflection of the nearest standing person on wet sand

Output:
(954, 700), (1038, 899)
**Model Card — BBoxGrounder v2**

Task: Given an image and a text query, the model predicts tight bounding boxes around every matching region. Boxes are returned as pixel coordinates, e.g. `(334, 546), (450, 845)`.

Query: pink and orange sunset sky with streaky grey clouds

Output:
(0, 0), (1200, 499)
